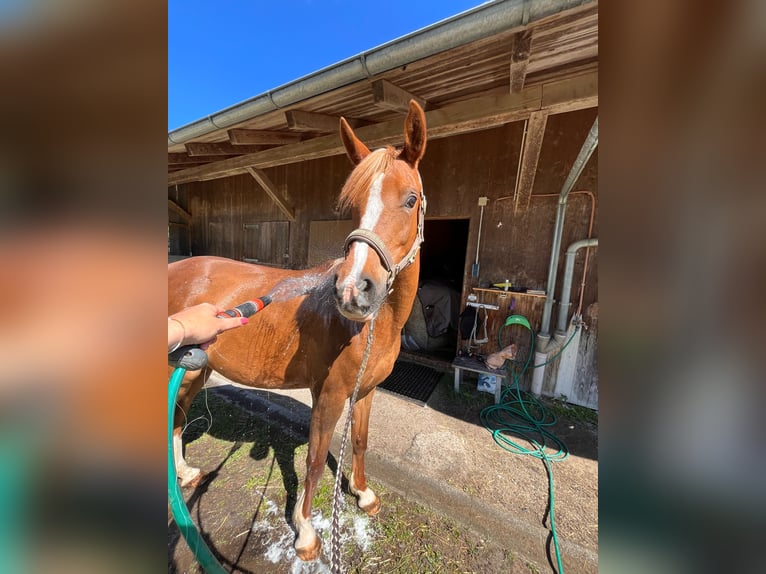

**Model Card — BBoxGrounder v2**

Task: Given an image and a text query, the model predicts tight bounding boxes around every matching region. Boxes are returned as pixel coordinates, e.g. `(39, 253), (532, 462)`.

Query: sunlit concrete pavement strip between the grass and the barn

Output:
(188, 364), (598, 573)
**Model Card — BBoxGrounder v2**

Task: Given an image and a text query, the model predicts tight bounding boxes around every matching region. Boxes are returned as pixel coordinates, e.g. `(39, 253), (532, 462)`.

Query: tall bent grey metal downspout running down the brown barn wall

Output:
(538, 116), (598, 344)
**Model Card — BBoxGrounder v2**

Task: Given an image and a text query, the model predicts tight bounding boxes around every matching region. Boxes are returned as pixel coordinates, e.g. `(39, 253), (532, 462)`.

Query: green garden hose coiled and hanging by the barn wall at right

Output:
(481, 315), (579, 574)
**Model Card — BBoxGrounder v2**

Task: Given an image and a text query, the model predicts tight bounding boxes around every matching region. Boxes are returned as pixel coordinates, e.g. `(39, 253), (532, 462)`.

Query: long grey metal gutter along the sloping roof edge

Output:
(168, 0), (585, 147)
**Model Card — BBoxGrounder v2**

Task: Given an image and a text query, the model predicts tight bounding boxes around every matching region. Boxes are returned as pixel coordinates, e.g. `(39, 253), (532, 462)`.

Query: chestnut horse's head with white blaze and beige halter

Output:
(335, 101), (426, 321)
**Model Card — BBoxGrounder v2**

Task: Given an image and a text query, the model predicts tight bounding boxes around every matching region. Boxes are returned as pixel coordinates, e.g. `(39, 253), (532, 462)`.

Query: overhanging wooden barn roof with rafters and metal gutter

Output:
(168, 0), (598, 185)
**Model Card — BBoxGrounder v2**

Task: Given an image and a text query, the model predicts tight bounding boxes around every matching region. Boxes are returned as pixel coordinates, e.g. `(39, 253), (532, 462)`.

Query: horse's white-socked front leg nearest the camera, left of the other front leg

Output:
(293, 392), (346, 561)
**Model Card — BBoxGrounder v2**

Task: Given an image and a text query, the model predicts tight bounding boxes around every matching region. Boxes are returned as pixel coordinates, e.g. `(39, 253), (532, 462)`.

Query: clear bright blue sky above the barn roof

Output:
(168, 0), (483, 130)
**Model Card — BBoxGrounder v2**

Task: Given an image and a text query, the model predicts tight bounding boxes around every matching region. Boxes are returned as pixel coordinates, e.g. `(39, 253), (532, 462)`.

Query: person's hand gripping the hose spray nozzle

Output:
(168, 303), (248, 353)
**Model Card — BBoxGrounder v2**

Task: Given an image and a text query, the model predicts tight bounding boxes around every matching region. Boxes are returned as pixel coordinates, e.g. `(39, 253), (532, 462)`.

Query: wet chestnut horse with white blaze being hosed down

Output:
(168, 101), (426, 560)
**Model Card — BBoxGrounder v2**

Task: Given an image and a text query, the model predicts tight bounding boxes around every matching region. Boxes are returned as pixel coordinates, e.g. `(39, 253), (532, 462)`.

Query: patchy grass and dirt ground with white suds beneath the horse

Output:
(168, 386), (528, 574)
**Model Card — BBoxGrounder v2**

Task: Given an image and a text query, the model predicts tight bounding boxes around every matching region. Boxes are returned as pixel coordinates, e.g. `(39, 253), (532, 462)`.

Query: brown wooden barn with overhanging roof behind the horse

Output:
(168, 0), (598, 414)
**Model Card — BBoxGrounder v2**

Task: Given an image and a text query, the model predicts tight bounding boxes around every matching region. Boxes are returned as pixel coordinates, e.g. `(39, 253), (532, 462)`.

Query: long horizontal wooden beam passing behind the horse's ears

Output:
(168, 71), (598, 185)
